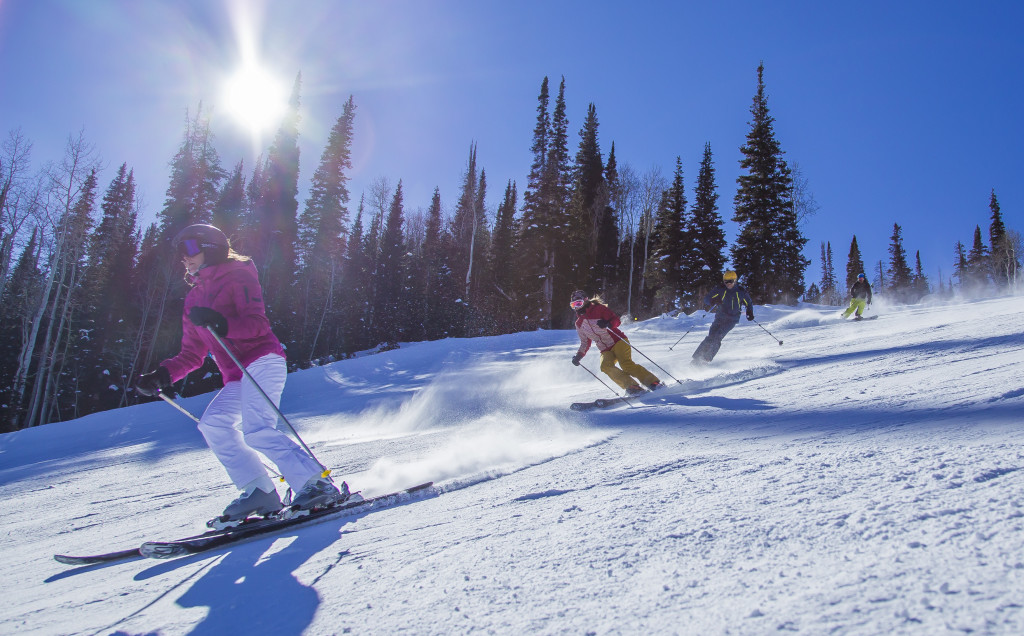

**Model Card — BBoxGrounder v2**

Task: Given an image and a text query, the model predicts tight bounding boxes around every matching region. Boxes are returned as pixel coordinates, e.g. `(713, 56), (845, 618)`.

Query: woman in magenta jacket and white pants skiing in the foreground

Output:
(135, 224), (348, 520)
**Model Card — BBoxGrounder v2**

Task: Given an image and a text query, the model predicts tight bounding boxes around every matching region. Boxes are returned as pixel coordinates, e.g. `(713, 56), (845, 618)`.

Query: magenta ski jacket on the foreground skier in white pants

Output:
(160, 260), (285, 382)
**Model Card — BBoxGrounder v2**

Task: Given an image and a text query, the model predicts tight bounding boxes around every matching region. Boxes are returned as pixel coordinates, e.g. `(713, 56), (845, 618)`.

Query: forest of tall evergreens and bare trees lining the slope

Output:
(0, 66), (1021, 431)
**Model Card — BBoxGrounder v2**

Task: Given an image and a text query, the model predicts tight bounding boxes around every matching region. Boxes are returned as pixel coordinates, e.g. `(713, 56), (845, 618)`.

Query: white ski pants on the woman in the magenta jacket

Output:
(193, 353), (321, 492)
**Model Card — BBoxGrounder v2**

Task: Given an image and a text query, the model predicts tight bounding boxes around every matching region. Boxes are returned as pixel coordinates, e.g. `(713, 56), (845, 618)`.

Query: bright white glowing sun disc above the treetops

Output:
(222, 66), (288, 135)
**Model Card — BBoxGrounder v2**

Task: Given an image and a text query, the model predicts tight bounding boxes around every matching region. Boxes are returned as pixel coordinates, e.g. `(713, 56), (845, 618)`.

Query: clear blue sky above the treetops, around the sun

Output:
(0, 0), (1024, 283)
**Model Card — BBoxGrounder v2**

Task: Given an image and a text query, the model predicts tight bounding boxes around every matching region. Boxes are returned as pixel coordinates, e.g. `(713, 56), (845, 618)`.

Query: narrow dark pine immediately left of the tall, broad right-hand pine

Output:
(689, 142), (726, 307)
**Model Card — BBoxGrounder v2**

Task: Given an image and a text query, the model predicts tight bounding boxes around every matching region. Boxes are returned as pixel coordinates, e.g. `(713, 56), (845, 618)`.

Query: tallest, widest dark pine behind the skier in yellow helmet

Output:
(732, 63), (809, 304)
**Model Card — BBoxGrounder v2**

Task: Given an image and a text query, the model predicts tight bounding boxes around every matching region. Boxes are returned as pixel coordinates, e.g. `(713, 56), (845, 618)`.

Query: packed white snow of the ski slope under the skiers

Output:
(0, 297), (1024, 634)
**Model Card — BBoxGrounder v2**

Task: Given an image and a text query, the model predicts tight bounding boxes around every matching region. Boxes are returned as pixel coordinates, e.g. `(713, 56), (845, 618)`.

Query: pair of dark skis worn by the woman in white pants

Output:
(53, 481), (433, 565)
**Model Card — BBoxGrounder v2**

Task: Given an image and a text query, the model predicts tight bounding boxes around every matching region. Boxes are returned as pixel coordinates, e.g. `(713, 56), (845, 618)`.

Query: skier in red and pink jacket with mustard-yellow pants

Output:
(569, 290), (662, 395)
